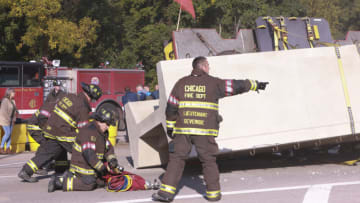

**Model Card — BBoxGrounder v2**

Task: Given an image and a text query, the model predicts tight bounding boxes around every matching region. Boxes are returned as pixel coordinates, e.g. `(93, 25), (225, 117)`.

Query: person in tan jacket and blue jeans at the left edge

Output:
(0, 88), (16, 154)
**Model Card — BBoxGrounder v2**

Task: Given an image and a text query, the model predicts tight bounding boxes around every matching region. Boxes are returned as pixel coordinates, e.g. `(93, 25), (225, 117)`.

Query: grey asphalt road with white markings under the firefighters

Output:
(0, 144), (360, 203)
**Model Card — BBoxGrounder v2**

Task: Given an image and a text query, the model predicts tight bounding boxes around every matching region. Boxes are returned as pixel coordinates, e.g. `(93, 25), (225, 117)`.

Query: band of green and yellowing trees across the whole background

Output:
(0, 0), (360, 87)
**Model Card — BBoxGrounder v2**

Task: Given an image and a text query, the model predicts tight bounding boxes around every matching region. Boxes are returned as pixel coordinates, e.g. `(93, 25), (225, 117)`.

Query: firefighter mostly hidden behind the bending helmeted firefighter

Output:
(26, 80), (68, 175)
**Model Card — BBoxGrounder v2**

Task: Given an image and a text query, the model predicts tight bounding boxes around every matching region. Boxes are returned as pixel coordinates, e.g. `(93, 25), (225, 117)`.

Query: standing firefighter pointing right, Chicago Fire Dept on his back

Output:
(152, 56), (268, 202)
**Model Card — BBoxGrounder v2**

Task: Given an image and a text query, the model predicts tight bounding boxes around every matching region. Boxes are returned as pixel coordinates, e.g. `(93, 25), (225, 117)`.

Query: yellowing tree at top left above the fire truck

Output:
(2, 0), (99, 58)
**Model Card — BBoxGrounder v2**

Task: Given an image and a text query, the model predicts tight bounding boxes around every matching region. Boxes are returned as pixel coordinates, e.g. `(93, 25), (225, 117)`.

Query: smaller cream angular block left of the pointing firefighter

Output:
(125, 100), (168, 168)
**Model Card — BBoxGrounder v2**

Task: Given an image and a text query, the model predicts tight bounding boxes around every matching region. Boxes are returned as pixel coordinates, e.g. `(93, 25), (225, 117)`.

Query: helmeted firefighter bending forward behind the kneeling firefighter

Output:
(18, 83), (102, 182)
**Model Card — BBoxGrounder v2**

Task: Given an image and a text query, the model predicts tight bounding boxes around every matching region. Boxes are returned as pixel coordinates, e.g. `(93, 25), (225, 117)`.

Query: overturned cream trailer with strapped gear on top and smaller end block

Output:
(125, 16), (360, 168)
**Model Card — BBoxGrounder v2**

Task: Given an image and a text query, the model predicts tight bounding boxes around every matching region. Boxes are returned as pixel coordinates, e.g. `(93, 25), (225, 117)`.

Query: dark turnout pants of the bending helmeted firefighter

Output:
(23, 139), (72, 175)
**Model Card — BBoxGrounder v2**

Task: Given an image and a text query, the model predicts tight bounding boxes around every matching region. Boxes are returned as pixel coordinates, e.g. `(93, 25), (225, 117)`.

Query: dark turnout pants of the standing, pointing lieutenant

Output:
(158, 135), (220, 198)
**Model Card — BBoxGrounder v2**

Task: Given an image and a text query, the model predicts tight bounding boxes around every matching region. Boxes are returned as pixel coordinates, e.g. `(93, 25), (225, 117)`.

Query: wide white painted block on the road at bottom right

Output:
(303, 185), (332, 203)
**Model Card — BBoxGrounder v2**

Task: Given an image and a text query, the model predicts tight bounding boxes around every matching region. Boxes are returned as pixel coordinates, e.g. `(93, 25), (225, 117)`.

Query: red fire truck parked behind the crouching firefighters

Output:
(0, 61), (145, 129)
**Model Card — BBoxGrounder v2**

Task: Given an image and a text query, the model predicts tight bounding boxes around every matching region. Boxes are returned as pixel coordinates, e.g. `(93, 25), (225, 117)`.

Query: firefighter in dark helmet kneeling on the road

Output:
(48, 108), (123, 192)
